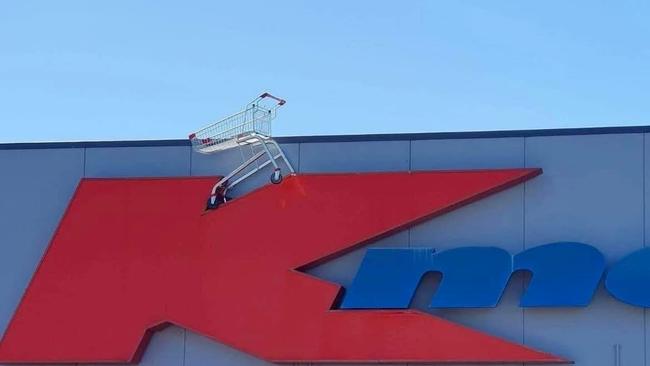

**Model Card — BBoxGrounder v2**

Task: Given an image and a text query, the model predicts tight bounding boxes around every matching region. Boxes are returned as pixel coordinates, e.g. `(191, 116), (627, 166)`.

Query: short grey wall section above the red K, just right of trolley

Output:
(300, 141), (410, 172)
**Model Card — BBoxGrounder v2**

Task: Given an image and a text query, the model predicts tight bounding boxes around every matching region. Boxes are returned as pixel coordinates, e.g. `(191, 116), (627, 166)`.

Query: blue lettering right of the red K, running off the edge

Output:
(341, 242), (608, 309)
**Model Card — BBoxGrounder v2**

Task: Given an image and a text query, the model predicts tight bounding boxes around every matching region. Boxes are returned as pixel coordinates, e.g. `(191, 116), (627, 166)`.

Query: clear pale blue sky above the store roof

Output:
(0, 0), (650, 142)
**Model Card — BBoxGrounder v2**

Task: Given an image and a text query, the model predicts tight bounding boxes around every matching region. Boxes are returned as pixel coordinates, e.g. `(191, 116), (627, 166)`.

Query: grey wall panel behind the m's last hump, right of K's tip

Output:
(524, 134), (645, 366)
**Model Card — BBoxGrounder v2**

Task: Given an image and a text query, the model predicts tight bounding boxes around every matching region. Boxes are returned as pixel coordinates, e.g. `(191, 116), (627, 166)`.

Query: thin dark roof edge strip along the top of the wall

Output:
(0, 126), (650, 150)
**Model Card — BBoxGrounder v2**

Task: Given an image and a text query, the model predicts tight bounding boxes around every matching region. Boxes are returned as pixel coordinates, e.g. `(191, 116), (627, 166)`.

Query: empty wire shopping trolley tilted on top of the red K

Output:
(189, 93), (295, 209)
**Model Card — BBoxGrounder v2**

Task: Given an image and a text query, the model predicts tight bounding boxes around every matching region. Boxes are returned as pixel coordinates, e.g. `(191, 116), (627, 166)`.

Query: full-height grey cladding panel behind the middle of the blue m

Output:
(410, 138), (528, 343)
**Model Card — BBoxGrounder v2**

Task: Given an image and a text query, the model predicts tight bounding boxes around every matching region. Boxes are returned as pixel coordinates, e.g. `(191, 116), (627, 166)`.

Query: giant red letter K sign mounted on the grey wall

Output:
(0, 169), (566, 363)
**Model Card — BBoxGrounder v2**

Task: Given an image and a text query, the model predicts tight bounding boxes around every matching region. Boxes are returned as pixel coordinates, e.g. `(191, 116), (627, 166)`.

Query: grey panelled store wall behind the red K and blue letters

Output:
(0, 127), (650, 366)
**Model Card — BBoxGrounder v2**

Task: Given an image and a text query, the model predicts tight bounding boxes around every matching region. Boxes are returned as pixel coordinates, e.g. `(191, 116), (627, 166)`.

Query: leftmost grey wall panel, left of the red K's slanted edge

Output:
(0, 149), (83, 364)
